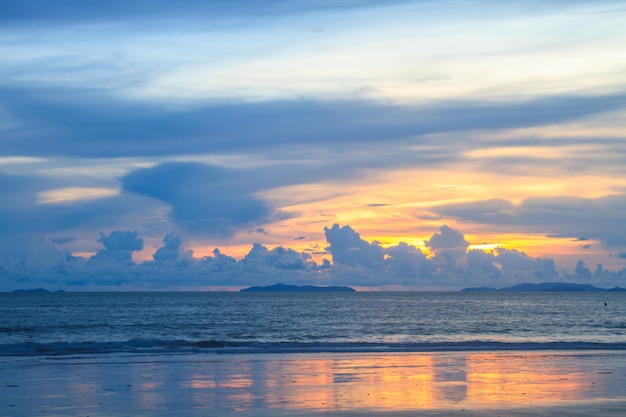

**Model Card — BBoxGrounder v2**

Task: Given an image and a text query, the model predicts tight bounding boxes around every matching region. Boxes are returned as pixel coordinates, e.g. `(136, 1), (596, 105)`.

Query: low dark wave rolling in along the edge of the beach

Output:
(0, 339), (626, 356)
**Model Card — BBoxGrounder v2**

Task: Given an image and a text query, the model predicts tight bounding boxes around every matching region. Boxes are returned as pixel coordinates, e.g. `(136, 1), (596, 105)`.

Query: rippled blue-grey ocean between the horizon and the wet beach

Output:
(0, 292), (626, 356)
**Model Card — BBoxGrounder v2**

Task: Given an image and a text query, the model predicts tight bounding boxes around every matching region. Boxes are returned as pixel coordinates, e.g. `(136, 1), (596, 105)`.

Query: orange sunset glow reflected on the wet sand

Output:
(174, 352), (626, 410)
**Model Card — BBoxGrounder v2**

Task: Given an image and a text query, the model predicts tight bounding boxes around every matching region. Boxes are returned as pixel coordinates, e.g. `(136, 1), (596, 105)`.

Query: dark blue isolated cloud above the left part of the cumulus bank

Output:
(121, 162), (273, 236)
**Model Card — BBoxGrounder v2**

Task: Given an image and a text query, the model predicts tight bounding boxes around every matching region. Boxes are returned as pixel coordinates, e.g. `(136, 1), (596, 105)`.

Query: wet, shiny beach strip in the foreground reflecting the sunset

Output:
(0, 351), (626, 417)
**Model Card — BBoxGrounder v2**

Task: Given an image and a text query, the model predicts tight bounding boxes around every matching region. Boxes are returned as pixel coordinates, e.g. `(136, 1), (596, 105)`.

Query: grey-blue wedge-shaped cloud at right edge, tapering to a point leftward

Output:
(431, 194), (626, 249)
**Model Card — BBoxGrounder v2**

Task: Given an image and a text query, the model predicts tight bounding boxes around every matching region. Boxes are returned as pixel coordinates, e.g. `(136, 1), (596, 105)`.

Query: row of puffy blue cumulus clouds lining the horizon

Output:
(0, 224), (626, 289)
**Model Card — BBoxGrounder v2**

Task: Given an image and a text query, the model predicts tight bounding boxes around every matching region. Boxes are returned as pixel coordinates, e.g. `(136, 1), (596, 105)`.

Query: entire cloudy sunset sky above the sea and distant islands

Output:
(0, 0), (626, 291)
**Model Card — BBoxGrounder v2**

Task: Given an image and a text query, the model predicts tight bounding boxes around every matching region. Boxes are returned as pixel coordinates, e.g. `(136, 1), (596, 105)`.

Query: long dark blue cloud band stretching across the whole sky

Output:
(0, 89), (626, 157)
